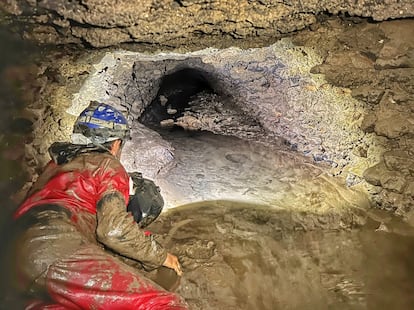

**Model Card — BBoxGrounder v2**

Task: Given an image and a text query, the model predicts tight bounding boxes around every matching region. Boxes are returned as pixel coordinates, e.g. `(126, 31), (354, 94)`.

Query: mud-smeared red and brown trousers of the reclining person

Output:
(12, 211), (187, 310)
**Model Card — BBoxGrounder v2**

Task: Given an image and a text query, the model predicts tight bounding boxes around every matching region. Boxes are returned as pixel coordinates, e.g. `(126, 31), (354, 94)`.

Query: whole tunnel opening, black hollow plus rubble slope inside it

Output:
(137, 67), (270, 145)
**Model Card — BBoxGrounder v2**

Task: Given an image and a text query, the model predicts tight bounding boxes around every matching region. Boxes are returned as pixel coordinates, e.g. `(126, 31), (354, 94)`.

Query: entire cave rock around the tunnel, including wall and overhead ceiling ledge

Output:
(0, 0), (414, 222)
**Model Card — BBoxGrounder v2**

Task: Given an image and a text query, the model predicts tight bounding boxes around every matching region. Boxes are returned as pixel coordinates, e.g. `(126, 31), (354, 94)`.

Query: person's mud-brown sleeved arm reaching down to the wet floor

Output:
(96, 192), (167, 269)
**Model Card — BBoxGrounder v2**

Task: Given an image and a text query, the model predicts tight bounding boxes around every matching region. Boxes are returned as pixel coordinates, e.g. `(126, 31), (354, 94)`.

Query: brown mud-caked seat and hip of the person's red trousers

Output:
(13, 205), (96, 296)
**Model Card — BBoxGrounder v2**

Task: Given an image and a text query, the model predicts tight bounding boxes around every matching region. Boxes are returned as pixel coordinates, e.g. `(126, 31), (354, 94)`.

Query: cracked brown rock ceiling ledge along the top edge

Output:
(0, 0), (414, 47)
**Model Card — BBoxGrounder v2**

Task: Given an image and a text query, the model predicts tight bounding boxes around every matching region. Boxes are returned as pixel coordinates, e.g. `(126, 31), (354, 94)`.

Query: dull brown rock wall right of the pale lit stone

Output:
(295, 20), (414, 223)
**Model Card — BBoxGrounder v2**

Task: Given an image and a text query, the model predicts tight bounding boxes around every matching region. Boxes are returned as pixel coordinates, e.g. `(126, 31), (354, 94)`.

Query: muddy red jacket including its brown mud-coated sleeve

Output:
(14, 148), (167, 268)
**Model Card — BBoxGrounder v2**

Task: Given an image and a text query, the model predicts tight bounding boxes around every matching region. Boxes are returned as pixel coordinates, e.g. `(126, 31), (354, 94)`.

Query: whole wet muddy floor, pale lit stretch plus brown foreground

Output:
(138, 124), (414, 309)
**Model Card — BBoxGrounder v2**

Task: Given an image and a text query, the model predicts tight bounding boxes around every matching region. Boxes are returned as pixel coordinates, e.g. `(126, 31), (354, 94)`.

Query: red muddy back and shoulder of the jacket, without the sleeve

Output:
(15, 153), (129, 220)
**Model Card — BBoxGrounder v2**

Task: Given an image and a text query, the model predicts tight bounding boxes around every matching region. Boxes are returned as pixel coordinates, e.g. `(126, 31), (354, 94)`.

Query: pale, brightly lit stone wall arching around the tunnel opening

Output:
(62, 39), (375, 182)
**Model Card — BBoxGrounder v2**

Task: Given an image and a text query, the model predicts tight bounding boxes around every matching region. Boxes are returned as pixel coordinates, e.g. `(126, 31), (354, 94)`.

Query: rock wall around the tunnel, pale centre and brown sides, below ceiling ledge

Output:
(11, 19), (414, 223)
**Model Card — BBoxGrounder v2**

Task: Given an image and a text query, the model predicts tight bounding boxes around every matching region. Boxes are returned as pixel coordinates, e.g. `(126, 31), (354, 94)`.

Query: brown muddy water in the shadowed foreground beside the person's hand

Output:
(151, 201), (414, 309)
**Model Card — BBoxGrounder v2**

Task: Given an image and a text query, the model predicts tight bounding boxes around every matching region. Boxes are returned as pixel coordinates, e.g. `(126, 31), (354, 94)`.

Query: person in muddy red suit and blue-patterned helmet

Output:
(10, 102), (187, 309)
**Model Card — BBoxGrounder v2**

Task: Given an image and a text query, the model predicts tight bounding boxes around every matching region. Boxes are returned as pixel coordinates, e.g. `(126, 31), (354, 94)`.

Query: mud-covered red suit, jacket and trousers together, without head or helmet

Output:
(14, 152), (187, 310)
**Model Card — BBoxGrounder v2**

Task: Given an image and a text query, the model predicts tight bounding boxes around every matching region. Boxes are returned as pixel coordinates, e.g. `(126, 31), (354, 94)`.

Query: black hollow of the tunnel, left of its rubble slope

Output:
(139, 68), (215, 128)
